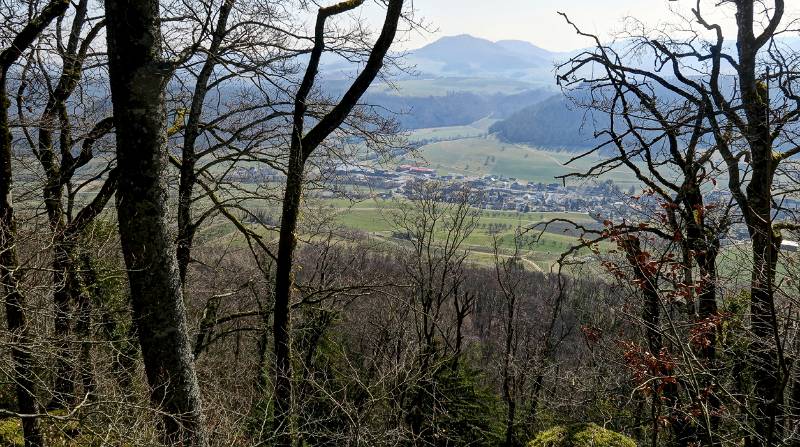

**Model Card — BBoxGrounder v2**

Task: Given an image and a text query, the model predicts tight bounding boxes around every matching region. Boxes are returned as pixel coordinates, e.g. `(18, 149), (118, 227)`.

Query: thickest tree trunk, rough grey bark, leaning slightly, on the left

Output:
(105, 0), (207, 446)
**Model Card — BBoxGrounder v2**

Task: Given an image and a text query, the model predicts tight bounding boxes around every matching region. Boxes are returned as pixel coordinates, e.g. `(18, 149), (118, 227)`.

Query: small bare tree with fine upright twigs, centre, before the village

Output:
(391, 180), (480, 442)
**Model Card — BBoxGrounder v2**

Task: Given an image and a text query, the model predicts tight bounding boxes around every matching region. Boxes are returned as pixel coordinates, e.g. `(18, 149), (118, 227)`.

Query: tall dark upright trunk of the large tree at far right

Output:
(737, 9), (784, 438)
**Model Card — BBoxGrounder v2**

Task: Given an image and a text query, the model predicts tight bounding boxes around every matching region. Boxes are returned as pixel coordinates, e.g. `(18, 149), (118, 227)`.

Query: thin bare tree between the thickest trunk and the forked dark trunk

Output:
(170, 1), (305, 283)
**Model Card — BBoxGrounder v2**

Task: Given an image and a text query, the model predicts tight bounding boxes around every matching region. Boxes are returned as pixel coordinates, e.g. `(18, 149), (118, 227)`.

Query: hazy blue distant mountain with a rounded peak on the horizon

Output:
(312, 34), (563, 129)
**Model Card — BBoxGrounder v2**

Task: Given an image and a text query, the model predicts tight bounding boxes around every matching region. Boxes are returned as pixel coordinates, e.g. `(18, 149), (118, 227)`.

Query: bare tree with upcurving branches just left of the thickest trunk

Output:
(11, 0), (117, 407)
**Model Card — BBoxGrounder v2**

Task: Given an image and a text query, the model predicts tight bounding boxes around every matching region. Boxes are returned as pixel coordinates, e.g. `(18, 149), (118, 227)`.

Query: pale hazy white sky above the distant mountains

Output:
(354, 0), (797, 51)
